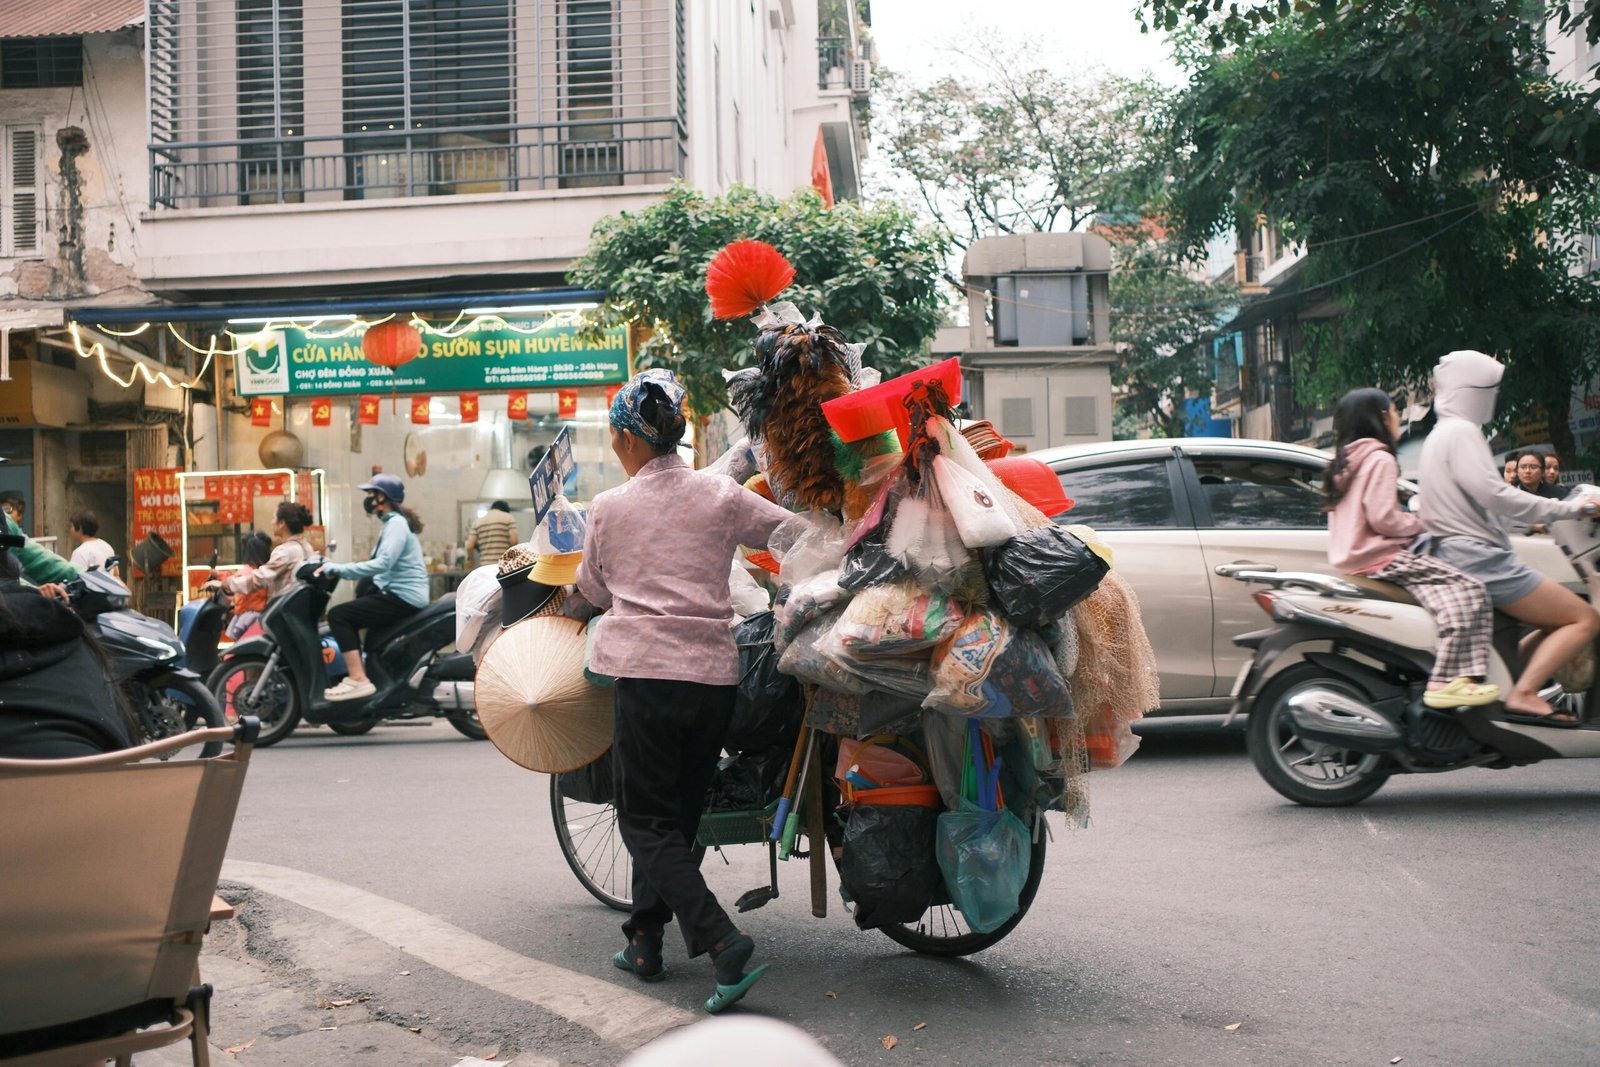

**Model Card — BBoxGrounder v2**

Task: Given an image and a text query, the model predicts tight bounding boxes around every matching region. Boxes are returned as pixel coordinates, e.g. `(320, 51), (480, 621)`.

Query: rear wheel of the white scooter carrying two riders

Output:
(1245, 662), (1392, 808)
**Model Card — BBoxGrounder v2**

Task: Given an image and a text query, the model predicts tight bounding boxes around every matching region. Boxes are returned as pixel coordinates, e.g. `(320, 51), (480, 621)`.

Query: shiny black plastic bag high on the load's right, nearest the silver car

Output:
(984, 525), (1110, 629)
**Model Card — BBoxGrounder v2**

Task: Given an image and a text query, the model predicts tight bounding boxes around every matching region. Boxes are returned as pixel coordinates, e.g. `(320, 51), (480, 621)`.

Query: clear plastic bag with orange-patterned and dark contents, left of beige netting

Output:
(923, 611), (1072, 718)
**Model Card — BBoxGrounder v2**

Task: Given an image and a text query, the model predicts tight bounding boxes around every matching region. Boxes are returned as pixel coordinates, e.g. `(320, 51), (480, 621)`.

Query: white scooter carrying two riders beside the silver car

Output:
(1216, 486), (1600, 808)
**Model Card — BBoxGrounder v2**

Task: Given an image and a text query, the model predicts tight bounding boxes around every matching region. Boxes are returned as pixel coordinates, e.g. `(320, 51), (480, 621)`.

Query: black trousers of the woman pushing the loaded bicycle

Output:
(613, 678), (738, 957)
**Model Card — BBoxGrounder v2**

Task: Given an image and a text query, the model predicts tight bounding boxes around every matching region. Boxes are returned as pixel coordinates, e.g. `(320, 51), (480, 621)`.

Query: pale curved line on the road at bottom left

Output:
(222, 859), (696, 1049)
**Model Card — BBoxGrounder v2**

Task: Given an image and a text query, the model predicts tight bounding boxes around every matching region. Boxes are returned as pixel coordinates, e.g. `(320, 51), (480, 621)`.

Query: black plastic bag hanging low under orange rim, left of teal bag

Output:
(838, 805), (944, 929)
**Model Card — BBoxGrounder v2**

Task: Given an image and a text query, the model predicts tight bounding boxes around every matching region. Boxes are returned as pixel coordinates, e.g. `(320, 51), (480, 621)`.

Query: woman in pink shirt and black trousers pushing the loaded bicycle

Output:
(578, 370), (789, 1014)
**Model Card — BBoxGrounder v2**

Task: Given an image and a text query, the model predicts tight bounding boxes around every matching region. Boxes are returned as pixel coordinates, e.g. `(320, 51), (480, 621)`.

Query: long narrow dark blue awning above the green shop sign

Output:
(70, 290), (605, 326)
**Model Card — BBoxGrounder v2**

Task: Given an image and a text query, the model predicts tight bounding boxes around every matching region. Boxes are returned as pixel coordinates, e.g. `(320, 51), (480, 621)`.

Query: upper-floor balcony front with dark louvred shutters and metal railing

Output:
(147, 0), (686, 208)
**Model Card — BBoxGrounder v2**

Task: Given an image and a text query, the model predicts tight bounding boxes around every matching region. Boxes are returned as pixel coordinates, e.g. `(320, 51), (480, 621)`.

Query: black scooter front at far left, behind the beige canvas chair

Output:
(66, 569), (227, 758)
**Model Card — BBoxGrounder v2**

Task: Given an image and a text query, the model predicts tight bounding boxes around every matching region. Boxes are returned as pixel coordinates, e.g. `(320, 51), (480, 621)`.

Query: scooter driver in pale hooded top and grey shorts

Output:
(1419, 350), (1600, 726)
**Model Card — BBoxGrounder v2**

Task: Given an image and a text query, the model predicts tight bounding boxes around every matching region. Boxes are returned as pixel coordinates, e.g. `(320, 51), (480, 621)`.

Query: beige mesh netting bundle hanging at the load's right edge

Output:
(1072, 573), (1162, 768)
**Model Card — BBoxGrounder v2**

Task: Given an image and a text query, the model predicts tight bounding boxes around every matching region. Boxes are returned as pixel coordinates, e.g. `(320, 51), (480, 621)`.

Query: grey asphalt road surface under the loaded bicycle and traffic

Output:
(216, 720), (1600, 1067)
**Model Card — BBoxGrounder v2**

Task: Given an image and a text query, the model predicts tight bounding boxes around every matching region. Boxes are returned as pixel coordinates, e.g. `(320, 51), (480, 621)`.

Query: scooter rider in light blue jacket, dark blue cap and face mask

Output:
(317, 474), (427, 701)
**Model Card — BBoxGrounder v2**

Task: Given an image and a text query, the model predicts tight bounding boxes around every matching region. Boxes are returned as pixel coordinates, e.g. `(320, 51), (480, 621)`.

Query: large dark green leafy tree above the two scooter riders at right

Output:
(1168, 0), (1600, 451)
